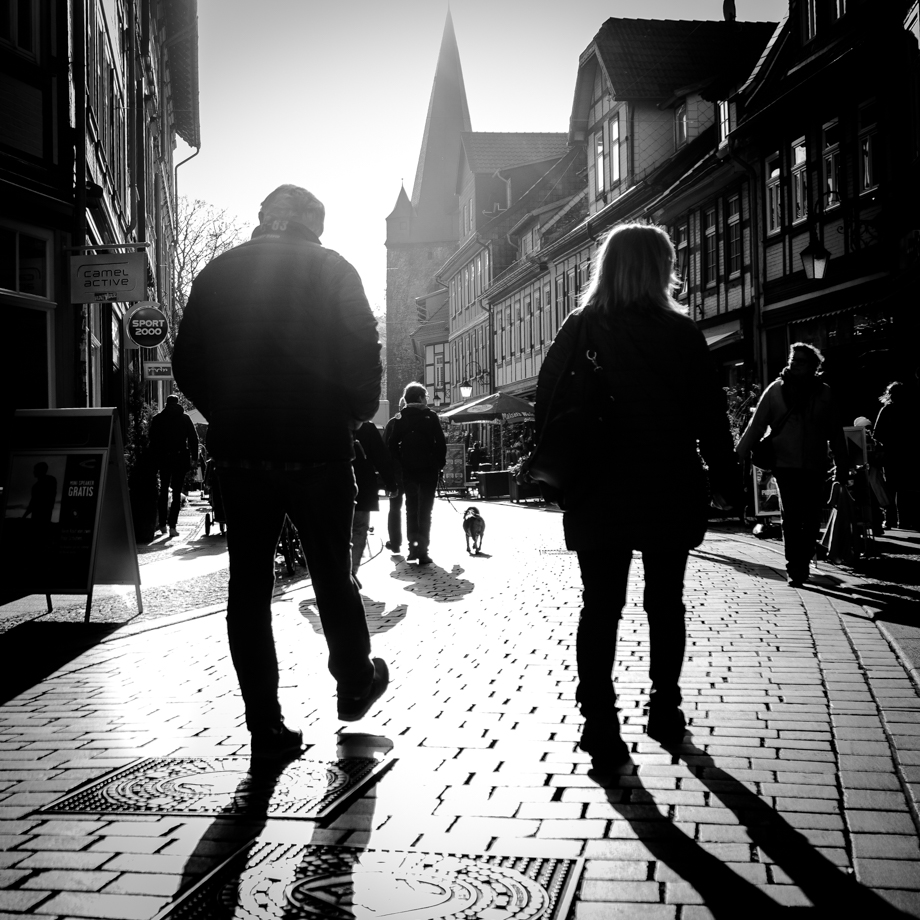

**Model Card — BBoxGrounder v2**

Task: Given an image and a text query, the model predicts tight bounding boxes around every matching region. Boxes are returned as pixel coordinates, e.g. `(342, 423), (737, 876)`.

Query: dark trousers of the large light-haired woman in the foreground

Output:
(575, 546), (689, 722)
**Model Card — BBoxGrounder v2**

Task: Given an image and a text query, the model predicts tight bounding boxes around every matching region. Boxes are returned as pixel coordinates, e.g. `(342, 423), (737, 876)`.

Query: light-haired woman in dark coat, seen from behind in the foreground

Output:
(536, 223), (739, 770)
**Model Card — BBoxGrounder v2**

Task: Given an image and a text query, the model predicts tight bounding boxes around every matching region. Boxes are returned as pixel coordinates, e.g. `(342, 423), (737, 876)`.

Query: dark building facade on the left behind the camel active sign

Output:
(0, 0), (200, 468)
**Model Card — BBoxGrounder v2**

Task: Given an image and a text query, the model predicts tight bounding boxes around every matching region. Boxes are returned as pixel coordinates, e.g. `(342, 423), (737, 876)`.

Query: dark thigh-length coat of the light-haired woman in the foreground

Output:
(536, 306), (740, 550)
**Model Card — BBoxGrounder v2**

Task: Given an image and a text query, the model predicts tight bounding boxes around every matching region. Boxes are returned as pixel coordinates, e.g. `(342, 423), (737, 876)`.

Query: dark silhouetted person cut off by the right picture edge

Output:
(875, 380), (920, 529)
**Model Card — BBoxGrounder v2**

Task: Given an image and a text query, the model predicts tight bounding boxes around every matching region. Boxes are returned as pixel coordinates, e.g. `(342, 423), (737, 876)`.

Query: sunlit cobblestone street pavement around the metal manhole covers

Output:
(0, 501), (920, 920)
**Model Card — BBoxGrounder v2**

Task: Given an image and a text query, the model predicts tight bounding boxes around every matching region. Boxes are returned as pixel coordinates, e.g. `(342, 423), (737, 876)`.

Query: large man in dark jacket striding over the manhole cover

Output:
(173, 185), (389, 757)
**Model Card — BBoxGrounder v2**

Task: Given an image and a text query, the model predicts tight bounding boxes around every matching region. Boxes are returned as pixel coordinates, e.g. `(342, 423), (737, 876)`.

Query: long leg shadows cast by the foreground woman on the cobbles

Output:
(589, 741), (908, 920)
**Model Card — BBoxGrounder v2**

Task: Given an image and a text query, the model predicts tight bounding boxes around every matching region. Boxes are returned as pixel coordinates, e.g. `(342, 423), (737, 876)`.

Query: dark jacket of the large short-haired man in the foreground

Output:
(173, 224), (381, 463)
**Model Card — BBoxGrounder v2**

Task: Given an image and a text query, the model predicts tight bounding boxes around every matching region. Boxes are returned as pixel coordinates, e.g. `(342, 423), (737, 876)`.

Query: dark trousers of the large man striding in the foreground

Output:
(218, 460), (374, 731)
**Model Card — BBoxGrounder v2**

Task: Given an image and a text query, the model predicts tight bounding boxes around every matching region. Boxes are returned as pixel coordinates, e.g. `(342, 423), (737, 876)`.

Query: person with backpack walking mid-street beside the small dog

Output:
(387, 382), (447, 565)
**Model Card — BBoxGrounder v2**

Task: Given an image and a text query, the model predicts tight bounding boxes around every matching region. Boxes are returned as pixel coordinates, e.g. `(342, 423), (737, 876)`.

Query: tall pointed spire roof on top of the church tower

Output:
(412, 10), (472, 240)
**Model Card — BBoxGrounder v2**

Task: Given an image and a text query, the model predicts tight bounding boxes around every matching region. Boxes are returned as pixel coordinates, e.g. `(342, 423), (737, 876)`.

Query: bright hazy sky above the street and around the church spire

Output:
(176, 0), (788, 312)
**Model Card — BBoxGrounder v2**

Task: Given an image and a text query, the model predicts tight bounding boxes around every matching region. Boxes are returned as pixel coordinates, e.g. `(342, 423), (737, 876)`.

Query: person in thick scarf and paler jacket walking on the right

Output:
(737, 342), (850, 587)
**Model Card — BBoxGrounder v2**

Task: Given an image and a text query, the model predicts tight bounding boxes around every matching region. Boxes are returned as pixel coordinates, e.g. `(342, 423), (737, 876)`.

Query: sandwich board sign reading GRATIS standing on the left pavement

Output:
(0, 408), (143, 623)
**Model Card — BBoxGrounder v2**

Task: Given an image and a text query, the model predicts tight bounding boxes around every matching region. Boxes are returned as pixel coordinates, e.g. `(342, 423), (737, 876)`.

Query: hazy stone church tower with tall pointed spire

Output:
(386, 10), (472, 414)
